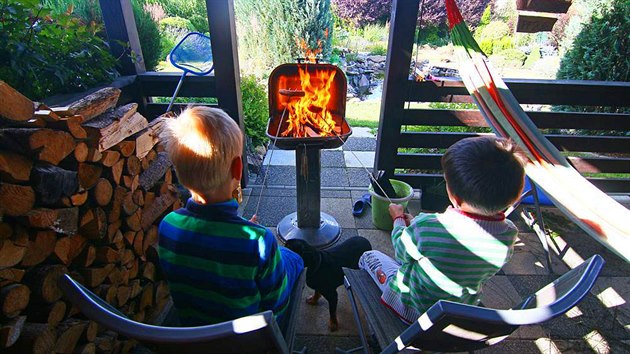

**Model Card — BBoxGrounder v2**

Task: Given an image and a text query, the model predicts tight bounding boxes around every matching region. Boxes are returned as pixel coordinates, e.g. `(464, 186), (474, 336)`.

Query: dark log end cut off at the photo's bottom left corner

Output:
(6, 322), (57, 354)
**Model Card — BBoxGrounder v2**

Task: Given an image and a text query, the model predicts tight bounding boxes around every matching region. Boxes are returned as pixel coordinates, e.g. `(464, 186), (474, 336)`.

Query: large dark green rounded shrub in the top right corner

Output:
(556, 0), (630, 81)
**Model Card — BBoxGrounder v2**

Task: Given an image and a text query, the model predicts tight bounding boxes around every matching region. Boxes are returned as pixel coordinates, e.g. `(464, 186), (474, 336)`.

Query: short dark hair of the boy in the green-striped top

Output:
(442, 136), (525, 214)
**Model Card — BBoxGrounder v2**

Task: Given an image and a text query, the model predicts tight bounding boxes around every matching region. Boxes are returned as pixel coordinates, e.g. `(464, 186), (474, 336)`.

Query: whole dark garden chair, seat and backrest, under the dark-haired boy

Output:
(337, 255), (604, 353)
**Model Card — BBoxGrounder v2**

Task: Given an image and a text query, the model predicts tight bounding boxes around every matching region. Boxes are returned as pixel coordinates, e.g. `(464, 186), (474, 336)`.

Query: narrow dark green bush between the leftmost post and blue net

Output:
(132, 0), (162, 71)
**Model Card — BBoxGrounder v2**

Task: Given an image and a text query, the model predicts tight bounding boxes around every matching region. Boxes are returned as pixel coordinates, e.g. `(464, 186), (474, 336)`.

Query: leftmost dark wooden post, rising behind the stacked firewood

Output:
(99, 0), (146, 75)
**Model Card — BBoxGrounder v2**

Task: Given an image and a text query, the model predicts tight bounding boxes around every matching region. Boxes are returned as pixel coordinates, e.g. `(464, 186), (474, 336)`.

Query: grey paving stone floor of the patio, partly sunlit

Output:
(242, 128), (630, 354)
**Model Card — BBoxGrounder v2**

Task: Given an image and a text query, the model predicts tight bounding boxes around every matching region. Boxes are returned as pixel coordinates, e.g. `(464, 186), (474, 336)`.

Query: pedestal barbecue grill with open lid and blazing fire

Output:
(267, 63), (352, 248)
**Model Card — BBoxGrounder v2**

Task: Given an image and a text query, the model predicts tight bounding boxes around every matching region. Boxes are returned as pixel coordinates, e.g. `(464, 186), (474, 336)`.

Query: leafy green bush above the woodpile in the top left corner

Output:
(0, 0), (116, 100)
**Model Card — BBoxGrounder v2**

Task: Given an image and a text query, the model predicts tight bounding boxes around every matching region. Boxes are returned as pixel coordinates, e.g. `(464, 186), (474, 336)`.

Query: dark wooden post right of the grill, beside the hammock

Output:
(374, 0), (420, 176)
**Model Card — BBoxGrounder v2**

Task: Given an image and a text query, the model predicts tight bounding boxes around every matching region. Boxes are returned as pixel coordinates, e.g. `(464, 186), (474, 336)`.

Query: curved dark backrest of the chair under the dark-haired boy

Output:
(383, 255), (604, 353)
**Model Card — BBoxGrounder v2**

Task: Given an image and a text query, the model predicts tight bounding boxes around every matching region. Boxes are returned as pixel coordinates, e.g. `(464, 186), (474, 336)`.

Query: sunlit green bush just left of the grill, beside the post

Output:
(241, 75), (269, 146)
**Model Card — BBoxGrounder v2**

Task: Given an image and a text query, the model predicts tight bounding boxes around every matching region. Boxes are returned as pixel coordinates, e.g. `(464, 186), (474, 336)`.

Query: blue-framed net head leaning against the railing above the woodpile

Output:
(169, 32), (213, 75)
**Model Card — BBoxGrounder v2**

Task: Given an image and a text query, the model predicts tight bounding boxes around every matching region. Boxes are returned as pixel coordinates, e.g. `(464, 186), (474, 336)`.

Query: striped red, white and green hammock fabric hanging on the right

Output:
(446, 0), (630, 262)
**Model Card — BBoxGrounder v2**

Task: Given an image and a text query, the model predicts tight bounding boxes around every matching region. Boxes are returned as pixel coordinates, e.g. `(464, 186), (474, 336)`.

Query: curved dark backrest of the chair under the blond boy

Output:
(59, 274), (289, 354)
